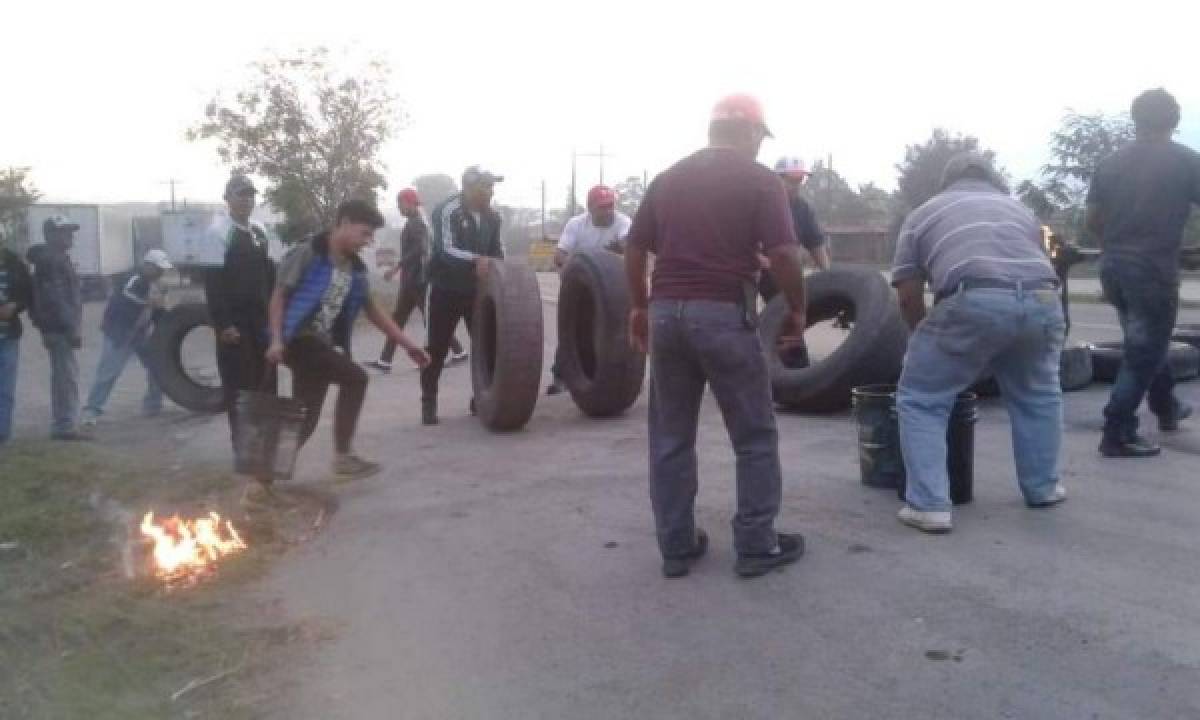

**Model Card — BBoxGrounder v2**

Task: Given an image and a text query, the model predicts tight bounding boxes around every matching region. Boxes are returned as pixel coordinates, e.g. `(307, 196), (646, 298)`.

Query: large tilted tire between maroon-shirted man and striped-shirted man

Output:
(758, 268), (908, 413)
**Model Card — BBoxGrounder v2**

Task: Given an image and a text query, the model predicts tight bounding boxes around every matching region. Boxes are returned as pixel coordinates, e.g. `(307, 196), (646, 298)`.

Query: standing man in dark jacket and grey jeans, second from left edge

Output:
(29, 215), (88, 440)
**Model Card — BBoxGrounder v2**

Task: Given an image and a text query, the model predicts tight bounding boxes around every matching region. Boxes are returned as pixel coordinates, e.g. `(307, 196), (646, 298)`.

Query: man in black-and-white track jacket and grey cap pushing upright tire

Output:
(421, 166), (504, 425)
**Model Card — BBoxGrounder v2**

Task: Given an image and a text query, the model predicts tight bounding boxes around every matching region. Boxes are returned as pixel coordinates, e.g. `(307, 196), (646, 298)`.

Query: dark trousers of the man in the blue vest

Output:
(284, 337), (367, 454)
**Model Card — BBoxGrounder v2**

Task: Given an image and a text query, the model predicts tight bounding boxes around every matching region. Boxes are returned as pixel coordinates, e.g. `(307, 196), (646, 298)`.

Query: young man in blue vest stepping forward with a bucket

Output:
(266, 200), (430, 480)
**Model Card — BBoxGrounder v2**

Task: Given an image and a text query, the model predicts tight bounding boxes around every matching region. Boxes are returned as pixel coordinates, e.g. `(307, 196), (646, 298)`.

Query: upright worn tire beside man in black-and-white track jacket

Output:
(470, 260), (542, 432)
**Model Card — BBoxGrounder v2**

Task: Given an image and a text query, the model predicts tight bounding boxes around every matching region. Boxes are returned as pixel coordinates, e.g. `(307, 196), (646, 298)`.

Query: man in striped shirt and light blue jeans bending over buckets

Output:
(892, 154), (1067, 533)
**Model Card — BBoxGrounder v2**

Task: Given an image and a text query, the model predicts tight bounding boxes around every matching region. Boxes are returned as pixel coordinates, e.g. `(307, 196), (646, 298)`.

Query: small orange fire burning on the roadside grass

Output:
(142, 511), (246, 582)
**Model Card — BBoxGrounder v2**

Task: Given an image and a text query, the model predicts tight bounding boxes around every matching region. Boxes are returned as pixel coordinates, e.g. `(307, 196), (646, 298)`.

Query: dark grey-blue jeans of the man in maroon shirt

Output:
(649, 300), (782, 557)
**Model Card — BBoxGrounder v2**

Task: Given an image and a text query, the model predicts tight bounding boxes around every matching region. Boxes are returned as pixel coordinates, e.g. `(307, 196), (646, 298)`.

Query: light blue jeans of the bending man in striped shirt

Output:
(896, 289), (1067, 511)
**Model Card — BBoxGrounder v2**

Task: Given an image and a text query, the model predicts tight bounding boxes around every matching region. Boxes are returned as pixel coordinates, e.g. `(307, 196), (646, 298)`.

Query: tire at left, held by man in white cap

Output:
(149, 302), (224, 413)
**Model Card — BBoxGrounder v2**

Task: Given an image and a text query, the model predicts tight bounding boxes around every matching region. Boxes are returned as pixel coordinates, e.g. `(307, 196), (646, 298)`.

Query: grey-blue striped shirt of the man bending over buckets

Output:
(892, 179), (1057, 293)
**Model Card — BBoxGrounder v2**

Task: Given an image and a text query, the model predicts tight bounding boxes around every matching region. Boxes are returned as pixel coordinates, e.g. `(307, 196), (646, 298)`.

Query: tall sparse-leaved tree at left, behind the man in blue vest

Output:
(188, 48), (406, 242)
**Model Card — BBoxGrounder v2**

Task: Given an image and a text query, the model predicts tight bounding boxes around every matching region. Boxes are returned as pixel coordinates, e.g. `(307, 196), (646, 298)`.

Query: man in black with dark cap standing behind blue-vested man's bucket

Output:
(204, 175), (275, 456)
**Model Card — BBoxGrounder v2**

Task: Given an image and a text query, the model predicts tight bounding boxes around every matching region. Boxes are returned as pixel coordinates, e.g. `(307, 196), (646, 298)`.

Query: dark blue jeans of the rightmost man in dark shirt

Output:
(1100, 259), (1180, 442)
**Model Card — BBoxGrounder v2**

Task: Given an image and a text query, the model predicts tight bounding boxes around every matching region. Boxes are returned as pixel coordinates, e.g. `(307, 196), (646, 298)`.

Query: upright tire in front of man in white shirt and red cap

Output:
(558, 250), (646, 418)
